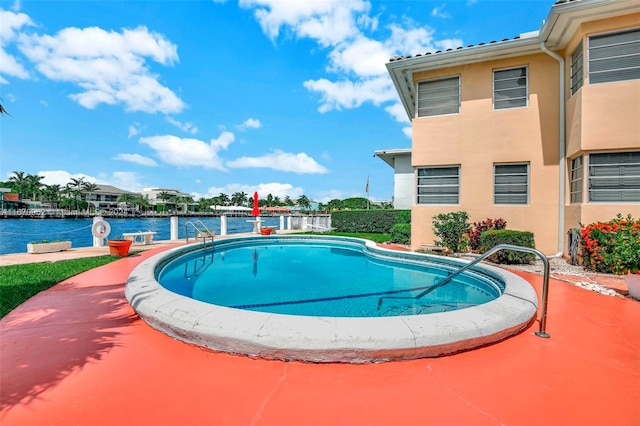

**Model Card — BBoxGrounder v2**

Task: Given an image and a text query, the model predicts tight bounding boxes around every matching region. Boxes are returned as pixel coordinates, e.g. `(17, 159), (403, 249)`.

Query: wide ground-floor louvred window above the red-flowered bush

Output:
(589, 151), (640, 202)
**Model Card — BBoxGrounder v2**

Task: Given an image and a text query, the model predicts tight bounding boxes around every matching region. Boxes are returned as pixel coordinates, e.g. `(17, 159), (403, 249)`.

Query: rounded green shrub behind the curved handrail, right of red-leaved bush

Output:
(480, 229), (536, 265)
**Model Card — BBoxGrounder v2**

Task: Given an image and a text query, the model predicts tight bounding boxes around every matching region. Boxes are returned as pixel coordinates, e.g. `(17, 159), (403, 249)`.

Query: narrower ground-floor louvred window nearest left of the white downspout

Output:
(493, 163), (529, 204)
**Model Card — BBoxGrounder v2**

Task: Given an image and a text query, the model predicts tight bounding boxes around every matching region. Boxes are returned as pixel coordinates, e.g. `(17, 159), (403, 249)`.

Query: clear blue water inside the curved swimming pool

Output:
(157, 237), (504, 317)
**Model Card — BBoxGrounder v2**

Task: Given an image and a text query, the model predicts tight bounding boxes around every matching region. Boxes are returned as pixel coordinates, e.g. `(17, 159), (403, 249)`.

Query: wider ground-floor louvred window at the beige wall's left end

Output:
(417, 166), (460, 204)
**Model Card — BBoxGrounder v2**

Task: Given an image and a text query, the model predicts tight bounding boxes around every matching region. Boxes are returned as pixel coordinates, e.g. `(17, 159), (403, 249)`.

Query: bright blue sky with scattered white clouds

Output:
(0, 0), (554, 203)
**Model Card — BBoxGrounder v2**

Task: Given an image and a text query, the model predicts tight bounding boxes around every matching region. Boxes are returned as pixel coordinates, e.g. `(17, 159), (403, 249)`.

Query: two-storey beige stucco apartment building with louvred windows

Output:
(384, 0), (640, 254)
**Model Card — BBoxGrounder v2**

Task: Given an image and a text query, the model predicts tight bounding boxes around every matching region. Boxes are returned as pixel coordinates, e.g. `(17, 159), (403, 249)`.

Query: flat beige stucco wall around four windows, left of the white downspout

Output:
(411, 53), (559, 254)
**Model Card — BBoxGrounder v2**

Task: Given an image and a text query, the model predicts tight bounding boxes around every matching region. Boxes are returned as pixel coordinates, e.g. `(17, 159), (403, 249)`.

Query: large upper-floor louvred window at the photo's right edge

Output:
(586, 27), (640, 84)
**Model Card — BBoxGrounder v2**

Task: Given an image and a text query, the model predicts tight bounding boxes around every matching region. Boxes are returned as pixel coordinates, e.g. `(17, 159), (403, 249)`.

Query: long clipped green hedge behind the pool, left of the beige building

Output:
(331, 210), (411, 234)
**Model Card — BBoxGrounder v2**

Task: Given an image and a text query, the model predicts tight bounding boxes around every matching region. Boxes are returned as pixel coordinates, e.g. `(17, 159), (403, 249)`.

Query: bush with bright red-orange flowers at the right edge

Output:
(580, 213), (640, 274)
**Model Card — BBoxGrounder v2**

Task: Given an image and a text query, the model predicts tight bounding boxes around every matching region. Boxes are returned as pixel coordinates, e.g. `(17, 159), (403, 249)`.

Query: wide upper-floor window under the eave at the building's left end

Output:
(417, 76), (460, 117)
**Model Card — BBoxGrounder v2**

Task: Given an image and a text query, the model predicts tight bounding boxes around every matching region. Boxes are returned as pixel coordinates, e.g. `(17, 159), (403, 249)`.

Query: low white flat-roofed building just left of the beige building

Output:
(373, 148), (415, 210)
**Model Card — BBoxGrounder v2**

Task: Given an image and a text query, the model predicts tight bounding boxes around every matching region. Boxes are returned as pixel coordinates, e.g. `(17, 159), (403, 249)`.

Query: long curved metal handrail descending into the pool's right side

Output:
(378, 244), (551, 338)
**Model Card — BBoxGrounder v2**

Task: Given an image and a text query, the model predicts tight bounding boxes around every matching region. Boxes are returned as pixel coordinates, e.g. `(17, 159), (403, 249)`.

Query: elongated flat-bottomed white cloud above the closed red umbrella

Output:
(226, 150), (328, 174)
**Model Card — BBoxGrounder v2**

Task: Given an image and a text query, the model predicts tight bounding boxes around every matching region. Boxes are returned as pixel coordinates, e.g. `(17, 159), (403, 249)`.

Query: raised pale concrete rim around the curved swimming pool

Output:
(125, 236), (538, 363)
